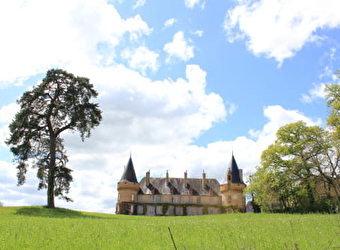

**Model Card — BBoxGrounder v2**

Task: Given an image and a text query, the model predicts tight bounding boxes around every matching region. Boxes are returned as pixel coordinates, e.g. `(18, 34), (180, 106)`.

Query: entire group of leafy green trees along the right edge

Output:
(246, 80), (340, 212)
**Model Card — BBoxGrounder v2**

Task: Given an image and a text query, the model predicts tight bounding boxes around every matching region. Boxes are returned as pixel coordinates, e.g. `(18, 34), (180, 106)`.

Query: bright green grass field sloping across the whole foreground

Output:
(0, 207), (340, 250)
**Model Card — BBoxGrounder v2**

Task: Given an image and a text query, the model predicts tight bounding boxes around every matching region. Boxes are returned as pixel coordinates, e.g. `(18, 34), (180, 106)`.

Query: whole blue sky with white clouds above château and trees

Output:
(0, 0), (340, 213)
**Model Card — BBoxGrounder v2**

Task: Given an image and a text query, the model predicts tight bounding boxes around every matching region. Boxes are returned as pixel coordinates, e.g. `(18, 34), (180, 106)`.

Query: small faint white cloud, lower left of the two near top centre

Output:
(122, 46), (159, 75)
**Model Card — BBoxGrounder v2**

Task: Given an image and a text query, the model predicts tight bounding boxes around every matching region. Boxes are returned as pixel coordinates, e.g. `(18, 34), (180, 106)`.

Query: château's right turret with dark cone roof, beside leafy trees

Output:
(220, 154), (246, 211)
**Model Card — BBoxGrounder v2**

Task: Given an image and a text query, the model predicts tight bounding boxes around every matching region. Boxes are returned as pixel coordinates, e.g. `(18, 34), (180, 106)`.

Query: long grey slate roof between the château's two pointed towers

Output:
(139, 177), (221, 196)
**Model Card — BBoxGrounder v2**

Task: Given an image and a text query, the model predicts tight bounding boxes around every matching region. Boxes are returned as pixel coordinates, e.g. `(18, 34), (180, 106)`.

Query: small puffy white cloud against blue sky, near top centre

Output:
(163, 31), (194, 63)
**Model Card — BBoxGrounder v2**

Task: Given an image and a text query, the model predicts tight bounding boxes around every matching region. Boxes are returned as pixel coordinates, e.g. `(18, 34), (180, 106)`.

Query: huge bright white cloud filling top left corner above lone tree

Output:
(0, 0), (152, 84)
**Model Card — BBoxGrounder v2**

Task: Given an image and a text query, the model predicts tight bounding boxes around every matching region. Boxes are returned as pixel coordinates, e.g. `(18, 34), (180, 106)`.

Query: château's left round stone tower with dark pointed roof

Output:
(116, 156), (140, 214)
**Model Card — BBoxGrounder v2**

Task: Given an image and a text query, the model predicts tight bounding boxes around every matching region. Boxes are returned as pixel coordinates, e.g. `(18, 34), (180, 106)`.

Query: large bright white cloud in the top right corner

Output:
(224, 0), (340, 64)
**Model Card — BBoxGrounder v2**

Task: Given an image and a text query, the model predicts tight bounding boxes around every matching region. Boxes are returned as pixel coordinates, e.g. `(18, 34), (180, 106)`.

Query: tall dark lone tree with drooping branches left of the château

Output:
(6, 69), (102, 208)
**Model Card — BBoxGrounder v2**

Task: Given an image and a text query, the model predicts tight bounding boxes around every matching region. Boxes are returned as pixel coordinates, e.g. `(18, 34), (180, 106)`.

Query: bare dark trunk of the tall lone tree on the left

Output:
(47, 135), (57, 208)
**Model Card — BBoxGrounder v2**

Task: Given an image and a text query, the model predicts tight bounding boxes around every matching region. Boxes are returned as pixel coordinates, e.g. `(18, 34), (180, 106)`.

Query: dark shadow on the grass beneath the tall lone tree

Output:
(15, 206), (113, 219)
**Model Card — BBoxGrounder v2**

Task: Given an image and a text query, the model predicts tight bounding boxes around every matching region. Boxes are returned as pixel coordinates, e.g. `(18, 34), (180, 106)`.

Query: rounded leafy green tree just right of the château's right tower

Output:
(248, 121), (330, 211)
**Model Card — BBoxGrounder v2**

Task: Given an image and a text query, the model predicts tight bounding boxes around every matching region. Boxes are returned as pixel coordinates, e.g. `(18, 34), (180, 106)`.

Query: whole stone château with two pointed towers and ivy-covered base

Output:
(116, 155), (246, 215)
